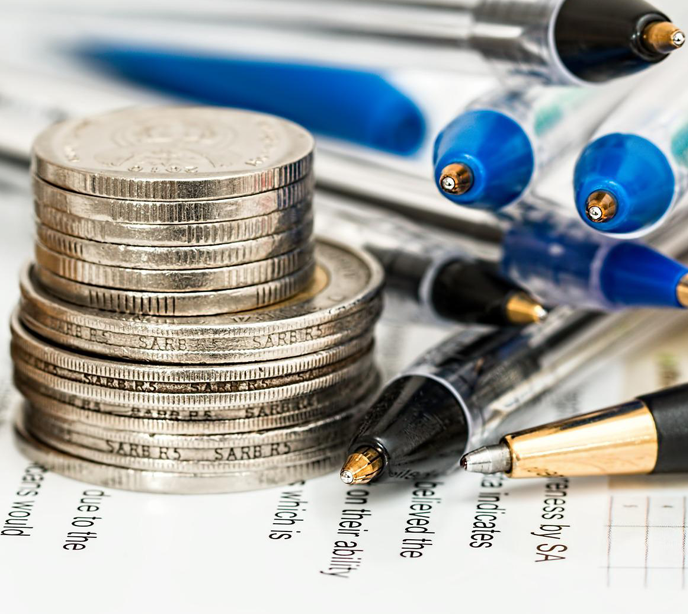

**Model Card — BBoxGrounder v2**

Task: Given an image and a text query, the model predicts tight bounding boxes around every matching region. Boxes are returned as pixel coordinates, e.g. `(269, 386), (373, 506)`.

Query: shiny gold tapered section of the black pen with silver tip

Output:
(502, 401), (658, 478)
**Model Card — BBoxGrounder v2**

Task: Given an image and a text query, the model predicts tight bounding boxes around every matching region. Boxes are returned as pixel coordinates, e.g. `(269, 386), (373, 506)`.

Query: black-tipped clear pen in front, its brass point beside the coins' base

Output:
(340, 309), (678, 484)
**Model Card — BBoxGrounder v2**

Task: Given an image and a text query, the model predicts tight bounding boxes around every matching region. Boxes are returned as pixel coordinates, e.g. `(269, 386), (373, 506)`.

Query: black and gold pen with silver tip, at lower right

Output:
(461, 384), (688, 478)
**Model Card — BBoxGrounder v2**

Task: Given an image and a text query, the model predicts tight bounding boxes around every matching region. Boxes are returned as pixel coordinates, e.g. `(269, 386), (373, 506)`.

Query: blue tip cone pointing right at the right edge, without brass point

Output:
(600, 242), (688, 308)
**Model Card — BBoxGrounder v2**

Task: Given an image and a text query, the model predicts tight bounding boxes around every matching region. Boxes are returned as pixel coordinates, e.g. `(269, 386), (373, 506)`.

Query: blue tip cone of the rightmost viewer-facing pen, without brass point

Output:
(574, 133), (676, 235)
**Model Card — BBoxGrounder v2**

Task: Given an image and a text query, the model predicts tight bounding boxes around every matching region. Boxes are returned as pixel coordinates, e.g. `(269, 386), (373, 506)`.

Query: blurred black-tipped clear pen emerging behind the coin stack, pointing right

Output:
(314, 193), (547, 326)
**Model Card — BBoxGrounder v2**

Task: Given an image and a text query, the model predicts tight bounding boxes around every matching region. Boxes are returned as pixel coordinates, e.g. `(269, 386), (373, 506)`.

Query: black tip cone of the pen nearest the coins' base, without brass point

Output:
(349, 375), (469, 481)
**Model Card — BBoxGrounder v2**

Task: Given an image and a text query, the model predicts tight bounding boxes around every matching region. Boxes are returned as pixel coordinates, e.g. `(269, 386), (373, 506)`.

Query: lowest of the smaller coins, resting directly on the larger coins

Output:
(33, 262), (315, 316)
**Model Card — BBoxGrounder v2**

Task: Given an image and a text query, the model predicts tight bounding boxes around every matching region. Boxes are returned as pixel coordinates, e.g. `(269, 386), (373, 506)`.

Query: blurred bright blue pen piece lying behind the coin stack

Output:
(79, 43), (425, 155)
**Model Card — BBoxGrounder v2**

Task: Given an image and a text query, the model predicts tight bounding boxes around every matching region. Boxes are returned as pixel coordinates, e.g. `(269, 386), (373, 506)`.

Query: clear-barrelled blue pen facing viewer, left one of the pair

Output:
(433, 83), (628, 210)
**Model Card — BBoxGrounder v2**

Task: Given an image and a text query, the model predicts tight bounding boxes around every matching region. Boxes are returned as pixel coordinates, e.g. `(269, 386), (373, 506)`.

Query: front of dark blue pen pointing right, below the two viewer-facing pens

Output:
(500, 203), (688, 311)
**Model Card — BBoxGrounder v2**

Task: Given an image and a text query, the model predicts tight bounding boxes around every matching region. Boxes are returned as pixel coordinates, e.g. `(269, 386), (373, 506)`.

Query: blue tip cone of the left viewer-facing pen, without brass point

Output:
(433, 110), (535, 210)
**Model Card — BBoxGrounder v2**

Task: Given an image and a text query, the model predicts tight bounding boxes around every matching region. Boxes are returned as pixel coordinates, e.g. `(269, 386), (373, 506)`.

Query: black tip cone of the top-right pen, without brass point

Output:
(554, 0), (669, 83)
